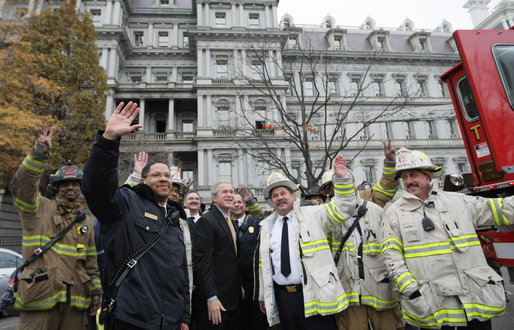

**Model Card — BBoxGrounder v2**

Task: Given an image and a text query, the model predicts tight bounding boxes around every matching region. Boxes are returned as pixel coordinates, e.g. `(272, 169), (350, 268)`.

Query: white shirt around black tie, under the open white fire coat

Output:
(269, 211), (302, 285)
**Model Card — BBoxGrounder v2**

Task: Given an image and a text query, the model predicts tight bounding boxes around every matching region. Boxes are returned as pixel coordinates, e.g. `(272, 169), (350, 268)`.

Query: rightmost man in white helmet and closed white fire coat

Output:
(379, 148), (514, 329)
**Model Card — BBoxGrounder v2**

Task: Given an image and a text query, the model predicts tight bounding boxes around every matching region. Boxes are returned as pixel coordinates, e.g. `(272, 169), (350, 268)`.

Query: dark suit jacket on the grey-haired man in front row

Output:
(193, 207), (241, 311)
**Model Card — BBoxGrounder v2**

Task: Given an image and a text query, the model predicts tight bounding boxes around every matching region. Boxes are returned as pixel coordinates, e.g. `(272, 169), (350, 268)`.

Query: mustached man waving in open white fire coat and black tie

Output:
(256, 155), (355, 330)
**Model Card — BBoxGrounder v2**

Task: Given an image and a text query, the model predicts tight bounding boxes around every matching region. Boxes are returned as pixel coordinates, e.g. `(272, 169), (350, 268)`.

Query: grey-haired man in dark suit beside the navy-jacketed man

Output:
(193, 182), (241, 330)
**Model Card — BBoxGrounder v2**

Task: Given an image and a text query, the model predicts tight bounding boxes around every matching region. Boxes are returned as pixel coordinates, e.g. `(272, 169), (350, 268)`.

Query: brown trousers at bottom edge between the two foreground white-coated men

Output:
(336, 305), (405, 330)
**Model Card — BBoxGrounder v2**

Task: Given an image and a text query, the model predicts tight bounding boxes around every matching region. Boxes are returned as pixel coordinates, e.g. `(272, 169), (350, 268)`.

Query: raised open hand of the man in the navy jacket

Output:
(103, 101), (143, 140)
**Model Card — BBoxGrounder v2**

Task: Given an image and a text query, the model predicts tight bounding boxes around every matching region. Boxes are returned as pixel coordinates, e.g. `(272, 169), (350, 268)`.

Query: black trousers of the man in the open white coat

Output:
(274, 284), (335, 330)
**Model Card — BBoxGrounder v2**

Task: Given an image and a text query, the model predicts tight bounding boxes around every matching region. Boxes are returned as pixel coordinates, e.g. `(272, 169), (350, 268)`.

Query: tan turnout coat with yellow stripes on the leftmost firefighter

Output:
(11, 151), (102, 311)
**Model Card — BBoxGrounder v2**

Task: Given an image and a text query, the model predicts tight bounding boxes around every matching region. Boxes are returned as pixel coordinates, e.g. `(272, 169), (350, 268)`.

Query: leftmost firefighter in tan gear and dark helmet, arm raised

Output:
(10, 125), (102, 329)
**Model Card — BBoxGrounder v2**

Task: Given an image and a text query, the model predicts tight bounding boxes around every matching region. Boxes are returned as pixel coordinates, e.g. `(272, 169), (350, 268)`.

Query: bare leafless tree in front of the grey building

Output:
(222, 42), (413, 189)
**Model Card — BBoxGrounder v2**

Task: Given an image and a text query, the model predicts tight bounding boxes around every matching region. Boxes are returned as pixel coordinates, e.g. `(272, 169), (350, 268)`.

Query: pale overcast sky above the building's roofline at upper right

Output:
(278, 0), (501, 30)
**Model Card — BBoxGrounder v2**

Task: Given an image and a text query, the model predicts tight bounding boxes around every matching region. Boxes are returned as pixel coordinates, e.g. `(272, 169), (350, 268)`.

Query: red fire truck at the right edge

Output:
(441, 28), (514, 266)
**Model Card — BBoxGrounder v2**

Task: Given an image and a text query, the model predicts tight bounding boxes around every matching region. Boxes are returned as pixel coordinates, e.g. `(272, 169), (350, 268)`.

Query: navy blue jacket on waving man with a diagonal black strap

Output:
(82, 133), (190, 329)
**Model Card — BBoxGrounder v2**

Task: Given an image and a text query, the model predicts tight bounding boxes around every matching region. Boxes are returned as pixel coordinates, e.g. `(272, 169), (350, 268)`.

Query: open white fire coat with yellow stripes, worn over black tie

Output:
(259, 178), (355, 325)
